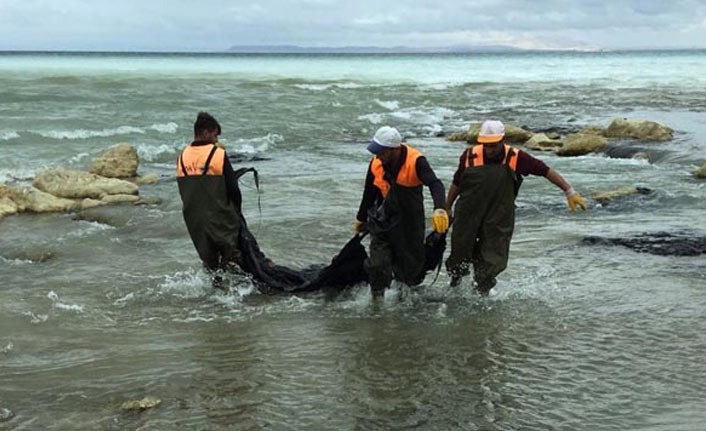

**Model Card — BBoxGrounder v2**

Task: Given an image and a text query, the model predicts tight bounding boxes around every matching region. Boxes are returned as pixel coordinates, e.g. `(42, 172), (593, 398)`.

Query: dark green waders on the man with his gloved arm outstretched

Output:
(446, 163), (519, 293)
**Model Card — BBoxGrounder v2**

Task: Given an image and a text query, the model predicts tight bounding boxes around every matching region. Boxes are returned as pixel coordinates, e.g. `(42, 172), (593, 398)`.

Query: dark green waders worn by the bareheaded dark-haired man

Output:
(177, 160), (240, 270)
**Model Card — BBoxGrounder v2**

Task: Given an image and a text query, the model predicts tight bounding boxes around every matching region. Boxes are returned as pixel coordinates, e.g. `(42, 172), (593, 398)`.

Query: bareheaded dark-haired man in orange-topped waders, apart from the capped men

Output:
(177, 112), (242, 270)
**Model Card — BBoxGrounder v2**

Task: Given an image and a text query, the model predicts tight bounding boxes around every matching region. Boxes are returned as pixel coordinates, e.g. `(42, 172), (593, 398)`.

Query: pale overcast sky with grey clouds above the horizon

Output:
(0, 0), (706, 51)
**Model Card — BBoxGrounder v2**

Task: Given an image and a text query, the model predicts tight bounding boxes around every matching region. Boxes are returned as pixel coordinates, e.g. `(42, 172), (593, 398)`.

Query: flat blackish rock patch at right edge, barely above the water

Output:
(582, 232), (706, 256)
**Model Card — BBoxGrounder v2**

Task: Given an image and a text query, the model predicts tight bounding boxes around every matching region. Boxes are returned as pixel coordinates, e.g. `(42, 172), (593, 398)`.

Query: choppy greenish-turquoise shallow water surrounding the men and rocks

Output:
(0, 52), (706, 430)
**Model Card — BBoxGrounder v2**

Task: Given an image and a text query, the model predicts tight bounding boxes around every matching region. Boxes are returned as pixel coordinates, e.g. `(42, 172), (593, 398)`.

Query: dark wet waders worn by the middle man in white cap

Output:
(365, 182), (424, 293)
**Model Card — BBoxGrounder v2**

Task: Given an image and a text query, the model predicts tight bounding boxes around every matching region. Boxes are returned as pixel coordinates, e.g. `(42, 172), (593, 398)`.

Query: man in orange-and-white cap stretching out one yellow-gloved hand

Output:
(446, 120), (586, 294)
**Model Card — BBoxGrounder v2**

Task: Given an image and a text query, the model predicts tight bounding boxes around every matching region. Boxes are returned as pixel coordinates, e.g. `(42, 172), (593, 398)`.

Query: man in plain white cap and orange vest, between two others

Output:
(353, 126), (449, 298)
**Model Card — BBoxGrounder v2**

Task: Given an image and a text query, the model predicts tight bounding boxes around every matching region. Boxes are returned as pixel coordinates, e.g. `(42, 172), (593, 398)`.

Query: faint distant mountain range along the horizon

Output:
(228, 45), (560, 54)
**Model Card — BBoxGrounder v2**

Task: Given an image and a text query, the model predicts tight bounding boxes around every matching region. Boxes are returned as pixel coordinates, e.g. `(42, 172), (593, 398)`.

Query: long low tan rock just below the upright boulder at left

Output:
(32, 170), (138, 199)
